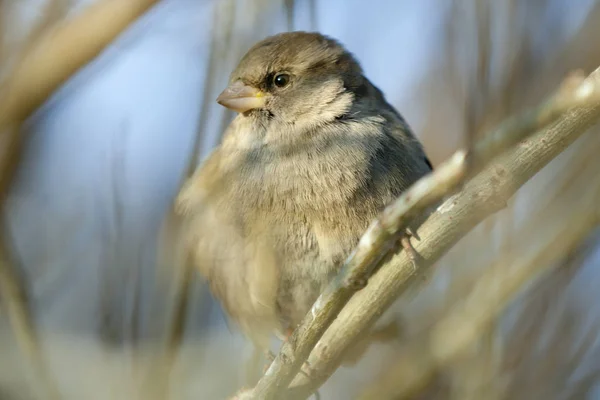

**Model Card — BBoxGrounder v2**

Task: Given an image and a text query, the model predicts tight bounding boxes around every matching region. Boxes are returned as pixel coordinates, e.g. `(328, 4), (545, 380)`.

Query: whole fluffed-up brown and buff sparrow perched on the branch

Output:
(175, 32), (431, 368)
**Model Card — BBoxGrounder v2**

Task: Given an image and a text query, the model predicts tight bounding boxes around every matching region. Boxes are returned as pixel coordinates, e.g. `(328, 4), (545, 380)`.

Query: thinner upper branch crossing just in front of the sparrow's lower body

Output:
(248, 63), (600, 399)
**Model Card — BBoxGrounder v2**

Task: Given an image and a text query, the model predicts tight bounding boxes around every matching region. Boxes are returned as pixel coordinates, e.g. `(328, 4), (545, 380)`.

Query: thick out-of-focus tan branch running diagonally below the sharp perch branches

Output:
(360, 137), (600, 399)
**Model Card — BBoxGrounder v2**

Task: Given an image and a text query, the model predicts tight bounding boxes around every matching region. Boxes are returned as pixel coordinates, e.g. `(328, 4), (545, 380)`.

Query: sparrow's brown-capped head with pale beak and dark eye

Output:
(217, 32), (364, 128)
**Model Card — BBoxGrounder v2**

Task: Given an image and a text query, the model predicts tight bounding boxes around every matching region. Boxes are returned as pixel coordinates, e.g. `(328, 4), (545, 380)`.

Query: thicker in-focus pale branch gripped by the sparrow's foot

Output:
(286, 70), (600, 399)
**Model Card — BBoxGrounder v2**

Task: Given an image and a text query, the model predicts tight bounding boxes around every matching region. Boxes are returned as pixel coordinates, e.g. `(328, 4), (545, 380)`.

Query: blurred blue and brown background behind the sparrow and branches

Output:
(0, 0), (600, 400)
